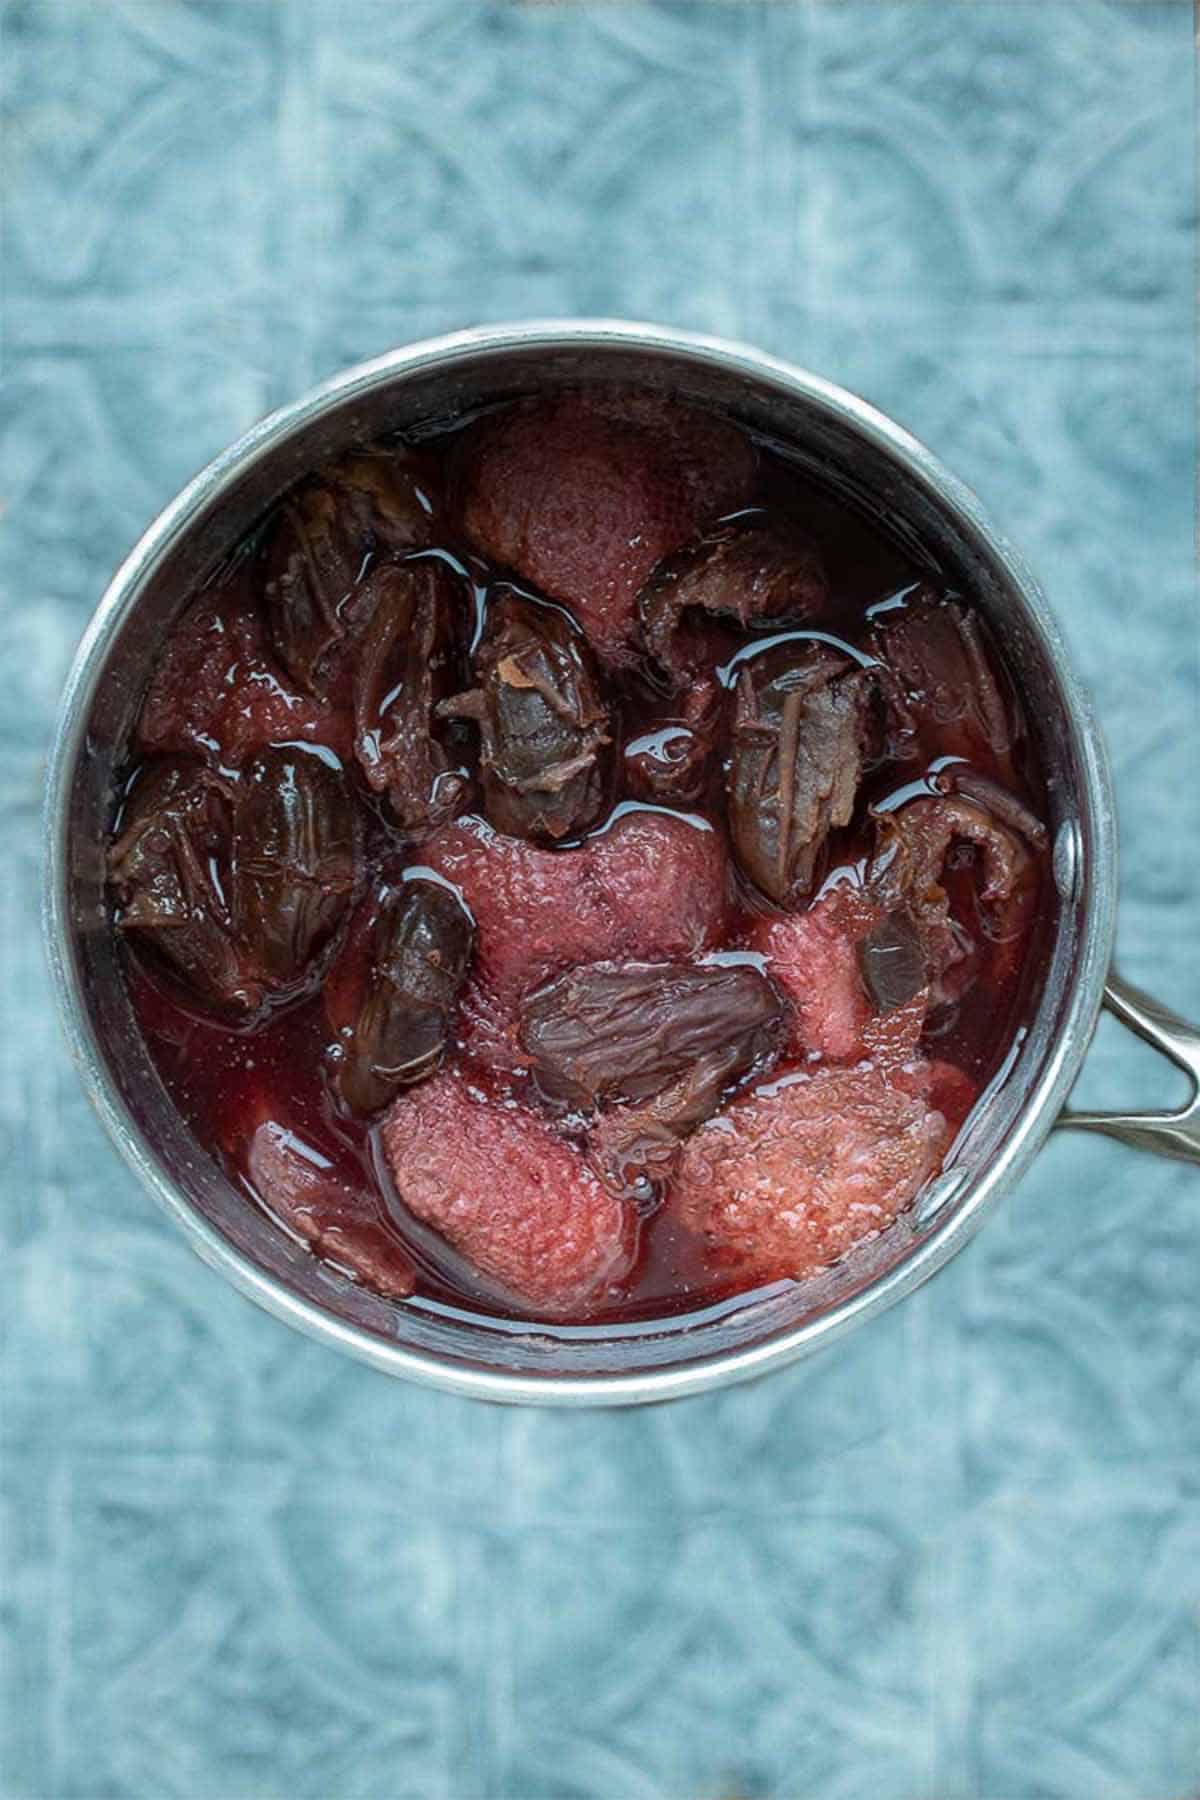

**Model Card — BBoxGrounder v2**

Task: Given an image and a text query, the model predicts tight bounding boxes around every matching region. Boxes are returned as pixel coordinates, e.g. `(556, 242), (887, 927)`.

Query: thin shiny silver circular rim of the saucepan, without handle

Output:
(43, 319), (1117, 1406)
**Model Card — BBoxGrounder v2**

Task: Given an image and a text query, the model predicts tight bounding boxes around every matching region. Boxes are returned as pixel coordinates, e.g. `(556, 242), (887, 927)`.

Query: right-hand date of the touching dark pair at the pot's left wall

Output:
(232, 745), (356, 986)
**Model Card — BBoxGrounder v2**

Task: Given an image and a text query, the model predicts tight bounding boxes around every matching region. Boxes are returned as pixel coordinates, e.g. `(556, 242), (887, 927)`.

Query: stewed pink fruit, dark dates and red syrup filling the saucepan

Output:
(108, 387), (1049, 1323)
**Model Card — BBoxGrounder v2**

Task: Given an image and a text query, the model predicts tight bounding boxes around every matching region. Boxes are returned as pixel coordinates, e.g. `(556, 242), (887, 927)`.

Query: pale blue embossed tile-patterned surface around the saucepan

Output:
(0, 0), (1200, 1800)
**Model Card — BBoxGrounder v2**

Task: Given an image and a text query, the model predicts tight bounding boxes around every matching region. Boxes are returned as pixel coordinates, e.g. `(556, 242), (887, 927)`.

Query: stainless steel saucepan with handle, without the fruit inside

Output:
(45, 320), (1200, 1404)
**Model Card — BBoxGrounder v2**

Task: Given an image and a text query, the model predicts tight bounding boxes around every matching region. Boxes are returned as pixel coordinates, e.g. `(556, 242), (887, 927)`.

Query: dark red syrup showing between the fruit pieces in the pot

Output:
(115, 390), (1049, 1325)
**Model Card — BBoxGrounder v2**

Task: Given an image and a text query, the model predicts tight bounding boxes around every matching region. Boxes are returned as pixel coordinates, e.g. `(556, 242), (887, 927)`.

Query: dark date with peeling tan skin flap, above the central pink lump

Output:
(439, 592), (612, 842)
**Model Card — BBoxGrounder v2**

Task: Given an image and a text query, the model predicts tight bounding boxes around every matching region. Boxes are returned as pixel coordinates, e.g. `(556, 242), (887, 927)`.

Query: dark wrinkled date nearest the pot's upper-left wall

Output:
(264, 450), (435, 695)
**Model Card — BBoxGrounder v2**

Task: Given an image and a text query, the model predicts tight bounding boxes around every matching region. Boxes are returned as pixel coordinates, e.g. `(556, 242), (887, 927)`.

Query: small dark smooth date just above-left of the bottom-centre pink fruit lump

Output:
(333, 880), (475, 1114)
